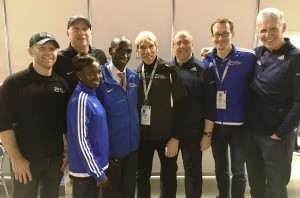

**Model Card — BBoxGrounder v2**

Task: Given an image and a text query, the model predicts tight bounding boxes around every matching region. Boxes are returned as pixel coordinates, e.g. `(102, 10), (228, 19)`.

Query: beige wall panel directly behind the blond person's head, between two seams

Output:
(91, 0), (172, 68)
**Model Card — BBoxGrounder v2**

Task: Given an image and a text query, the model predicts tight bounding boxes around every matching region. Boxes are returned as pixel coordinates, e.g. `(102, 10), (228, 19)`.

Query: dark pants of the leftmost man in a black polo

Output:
(11, 157), (63, 198)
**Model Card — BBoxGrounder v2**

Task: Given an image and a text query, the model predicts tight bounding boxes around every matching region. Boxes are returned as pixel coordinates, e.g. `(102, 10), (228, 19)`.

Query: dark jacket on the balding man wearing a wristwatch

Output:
(172, 55), (216, 140)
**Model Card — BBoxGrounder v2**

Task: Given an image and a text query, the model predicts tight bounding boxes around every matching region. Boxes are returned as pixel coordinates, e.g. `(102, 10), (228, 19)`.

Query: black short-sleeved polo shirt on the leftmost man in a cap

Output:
(0, 64), (70, 160)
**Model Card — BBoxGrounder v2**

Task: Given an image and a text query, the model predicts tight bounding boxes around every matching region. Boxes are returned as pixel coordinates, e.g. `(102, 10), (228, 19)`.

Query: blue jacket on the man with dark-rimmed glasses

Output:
(203, 45), (257, 125)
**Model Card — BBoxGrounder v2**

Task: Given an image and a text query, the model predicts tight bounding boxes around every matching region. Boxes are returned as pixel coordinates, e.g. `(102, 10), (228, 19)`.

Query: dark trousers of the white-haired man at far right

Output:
(246, 130), (295, 198)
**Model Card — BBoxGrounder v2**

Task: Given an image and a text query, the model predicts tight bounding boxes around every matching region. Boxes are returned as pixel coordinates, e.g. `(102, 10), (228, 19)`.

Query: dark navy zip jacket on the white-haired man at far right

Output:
(246, 38), (300, 138)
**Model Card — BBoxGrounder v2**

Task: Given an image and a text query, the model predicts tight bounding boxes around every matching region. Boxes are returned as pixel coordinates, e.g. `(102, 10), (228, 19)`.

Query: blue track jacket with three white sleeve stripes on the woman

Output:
(67, 82), (109, 181)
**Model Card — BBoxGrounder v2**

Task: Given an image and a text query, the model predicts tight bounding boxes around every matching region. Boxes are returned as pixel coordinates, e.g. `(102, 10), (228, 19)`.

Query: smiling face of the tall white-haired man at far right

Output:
(257, 18), (286, 51)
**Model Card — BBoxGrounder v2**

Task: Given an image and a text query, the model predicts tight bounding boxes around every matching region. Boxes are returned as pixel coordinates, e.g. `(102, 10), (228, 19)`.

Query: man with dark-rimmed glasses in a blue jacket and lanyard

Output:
(203, 18), (256, 198)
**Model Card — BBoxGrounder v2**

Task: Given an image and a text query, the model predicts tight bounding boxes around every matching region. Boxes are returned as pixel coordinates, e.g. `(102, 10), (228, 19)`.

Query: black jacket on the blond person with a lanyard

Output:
(137, 58), (186, 140)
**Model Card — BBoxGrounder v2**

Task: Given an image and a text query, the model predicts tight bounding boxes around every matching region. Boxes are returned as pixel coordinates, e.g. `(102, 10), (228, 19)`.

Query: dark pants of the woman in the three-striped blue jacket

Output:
(70, 176), (100, 198)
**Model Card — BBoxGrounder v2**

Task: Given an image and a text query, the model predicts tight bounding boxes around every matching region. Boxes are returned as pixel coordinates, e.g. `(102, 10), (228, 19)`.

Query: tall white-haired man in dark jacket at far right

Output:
(246, 8), (300, 198)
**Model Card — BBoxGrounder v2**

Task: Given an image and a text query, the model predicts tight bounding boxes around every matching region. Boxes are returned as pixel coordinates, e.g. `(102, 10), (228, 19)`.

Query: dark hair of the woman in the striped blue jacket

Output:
(73, 52), (100, 72)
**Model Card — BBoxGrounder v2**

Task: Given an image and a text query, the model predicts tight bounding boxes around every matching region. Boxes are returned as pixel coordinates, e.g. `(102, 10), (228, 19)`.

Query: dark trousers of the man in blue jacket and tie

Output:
(102, 151), (138, 198)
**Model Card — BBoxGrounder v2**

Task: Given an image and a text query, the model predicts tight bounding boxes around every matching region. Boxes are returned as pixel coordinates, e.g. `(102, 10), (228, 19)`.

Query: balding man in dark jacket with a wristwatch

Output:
(172, 30), (215, 198)
